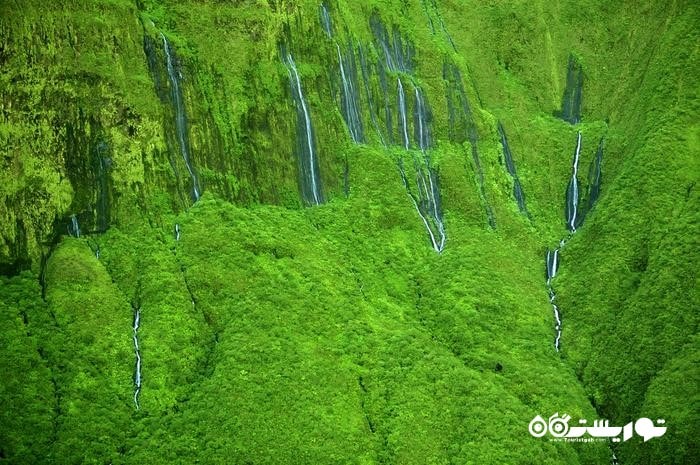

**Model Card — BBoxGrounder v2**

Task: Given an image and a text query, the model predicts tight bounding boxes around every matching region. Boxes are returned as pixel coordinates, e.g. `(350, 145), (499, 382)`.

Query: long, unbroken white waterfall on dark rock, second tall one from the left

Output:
(282, 53), (323, 205)
